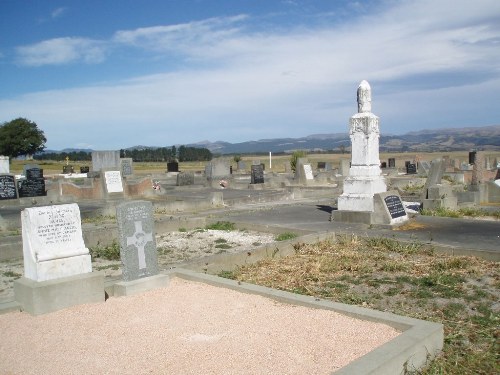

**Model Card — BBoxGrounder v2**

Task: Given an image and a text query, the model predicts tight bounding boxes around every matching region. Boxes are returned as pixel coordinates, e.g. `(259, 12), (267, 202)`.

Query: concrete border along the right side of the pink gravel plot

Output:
(167, 269), (444, 375)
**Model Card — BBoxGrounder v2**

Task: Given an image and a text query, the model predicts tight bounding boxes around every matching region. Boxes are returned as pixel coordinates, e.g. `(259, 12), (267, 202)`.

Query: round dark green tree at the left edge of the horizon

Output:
(0, 117), (47, 158)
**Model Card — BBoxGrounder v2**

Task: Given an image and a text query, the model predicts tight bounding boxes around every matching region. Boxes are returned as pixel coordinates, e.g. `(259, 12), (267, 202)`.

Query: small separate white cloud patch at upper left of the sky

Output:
(16, 37), (106, 66)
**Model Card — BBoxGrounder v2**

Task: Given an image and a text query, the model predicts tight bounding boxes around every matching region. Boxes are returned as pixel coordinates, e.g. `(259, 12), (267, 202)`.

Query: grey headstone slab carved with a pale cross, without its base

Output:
(116, 201), (158, 281)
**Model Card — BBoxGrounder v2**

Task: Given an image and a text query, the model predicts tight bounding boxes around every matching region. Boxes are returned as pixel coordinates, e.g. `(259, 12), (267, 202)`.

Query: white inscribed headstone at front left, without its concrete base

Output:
(21, 203), (92, 281)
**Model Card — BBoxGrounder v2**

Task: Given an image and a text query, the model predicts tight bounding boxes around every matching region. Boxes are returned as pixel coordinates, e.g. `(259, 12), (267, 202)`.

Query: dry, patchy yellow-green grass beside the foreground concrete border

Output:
(223, 236), (500, 375)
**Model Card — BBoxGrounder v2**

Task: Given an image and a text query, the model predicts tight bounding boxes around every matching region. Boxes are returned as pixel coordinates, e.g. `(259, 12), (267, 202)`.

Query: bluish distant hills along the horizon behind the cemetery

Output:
(44, 125), (500, 155)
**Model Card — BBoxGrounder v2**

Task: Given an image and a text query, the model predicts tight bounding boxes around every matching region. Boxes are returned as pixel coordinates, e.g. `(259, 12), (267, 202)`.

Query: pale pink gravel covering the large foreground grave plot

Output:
(0, 278), (399, 375)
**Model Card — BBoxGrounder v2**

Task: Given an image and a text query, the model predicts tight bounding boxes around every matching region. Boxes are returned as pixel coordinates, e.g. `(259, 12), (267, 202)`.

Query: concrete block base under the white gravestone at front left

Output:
(14, 271), (104, 315)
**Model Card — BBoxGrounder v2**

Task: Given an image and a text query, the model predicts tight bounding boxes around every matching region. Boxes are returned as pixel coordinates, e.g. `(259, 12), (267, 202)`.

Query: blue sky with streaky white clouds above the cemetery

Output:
(0, 0), (500, 150)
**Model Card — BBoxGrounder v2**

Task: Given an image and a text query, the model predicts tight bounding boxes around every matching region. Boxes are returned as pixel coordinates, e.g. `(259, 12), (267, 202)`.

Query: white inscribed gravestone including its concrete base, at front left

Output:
(14, 203), (104, 315)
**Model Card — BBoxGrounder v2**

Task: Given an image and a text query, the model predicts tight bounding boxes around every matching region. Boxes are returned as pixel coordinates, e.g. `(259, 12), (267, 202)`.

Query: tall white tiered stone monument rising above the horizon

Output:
(338, 81), (387, 212)
